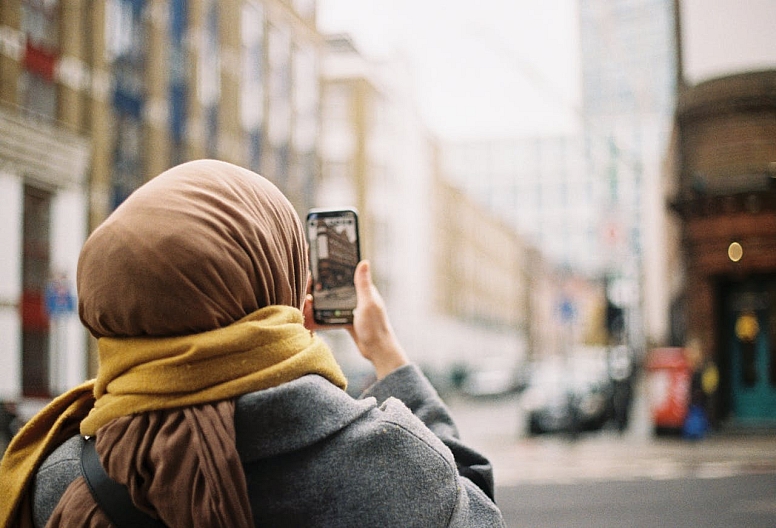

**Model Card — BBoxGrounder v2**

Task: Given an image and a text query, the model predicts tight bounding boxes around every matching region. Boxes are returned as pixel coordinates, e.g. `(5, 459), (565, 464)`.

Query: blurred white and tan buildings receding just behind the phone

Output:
(315, 35), (528, 388)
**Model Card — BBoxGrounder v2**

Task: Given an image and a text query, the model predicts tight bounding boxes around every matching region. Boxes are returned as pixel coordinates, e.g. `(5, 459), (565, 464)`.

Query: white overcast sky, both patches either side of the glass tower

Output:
(318, 0), (776, 139)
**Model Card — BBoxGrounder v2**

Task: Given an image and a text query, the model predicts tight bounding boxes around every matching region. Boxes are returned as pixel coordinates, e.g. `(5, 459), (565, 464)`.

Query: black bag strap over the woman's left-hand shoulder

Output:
(81, 437), (165, 528)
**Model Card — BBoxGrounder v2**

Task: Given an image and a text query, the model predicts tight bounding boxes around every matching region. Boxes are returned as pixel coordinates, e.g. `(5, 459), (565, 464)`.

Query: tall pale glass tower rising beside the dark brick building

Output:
(579, 0), (677, 346)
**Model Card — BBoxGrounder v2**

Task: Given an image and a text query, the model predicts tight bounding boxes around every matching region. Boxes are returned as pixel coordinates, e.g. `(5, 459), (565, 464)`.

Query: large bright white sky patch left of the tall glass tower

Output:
(318, 0), (579, 139)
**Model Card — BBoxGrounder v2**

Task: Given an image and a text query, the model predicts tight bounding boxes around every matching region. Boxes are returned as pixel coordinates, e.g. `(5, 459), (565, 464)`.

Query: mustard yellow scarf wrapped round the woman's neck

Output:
(0, 306), (346, 527)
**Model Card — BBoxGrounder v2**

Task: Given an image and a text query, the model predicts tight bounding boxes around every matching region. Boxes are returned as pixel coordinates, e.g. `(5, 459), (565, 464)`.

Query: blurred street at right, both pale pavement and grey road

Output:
(448, 376), (776, 528)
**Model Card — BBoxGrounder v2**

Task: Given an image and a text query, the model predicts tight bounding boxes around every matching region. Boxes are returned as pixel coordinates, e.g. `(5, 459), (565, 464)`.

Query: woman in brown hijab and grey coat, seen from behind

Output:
(0, 160), (503, 528)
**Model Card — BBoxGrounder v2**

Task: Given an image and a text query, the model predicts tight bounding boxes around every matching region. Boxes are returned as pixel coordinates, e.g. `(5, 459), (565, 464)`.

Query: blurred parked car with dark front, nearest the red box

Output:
(520, 358), (612, 435)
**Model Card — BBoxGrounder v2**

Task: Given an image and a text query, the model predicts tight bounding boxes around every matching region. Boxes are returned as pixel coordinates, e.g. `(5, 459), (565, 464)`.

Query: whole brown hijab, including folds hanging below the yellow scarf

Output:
(49, 160), (307, 527)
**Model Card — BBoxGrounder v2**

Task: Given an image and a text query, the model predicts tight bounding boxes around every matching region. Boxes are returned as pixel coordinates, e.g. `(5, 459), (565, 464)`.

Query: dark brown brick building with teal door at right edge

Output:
(672, 70), (776, 425)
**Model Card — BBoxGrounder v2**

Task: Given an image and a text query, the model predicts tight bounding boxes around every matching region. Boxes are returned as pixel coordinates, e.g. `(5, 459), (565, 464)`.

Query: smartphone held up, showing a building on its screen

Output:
(307, 208), (361, 325)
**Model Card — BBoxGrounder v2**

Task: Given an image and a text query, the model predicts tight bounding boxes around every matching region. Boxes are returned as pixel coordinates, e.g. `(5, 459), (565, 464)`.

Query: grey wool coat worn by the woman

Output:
(34, 365), (505, 528)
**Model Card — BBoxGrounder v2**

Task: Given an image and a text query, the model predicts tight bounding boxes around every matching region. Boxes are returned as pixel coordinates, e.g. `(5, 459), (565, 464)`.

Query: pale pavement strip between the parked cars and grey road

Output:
(448, 384), (776, 486)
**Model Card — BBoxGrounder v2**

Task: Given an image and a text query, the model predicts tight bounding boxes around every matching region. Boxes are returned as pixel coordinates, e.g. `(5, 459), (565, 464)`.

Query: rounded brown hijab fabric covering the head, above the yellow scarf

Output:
(77, 160), (307, 337)
